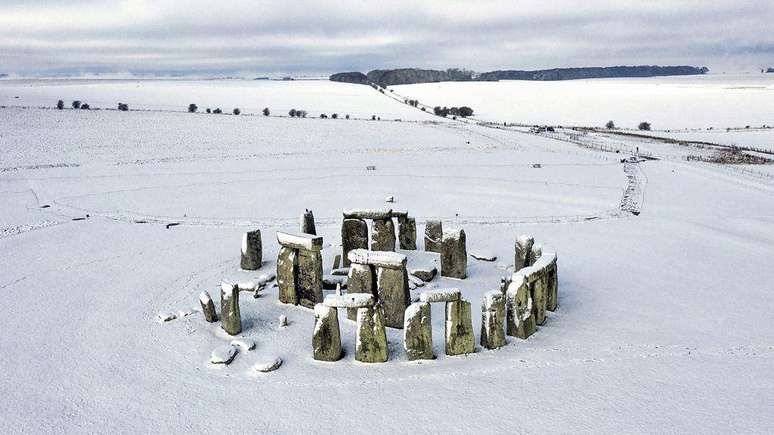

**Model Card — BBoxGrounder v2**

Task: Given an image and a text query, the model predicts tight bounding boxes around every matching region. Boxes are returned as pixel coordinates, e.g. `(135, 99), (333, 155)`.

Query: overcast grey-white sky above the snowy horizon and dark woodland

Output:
(0, 0), (774, 76)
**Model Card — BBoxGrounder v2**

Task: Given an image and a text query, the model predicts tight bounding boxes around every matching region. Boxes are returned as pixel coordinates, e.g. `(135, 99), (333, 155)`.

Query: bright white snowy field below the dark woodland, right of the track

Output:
(390, 74), (774, 130)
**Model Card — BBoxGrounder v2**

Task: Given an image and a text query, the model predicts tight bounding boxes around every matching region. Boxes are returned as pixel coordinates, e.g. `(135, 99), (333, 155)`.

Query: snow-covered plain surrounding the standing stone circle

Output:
(0, 82), (774, 433)
